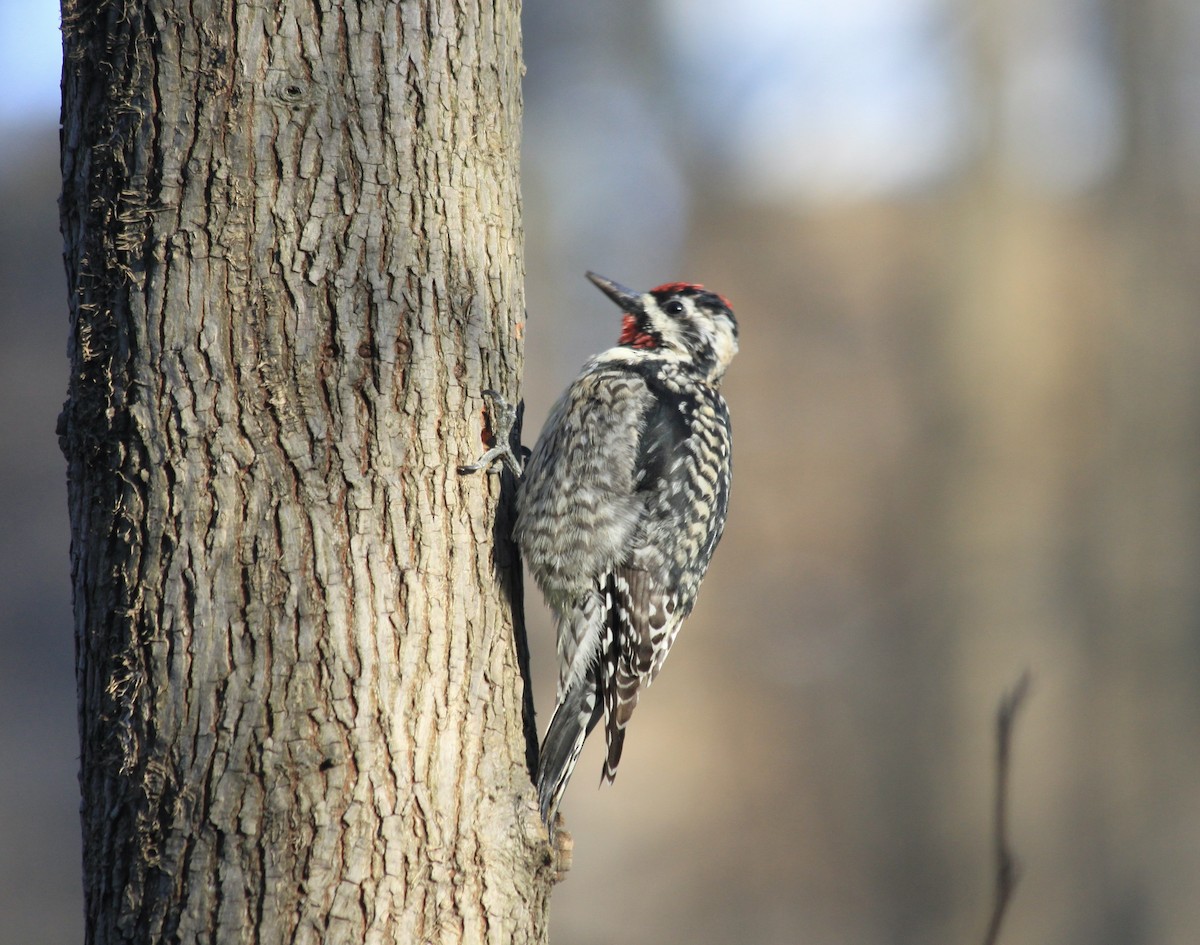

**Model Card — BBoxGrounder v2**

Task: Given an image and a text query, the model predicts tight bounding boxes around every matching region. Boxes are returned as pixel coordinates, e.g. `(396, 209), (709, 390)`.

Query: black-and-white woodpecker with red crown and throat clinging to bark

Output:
(464, 272), (738, 824)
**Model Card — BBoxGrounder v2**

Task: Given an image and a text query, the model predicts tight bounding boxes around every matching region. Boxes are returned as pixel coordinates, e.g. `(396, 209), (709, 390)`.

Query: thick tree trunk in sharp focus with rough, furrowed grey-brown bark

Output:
(60, 0), (551, 945)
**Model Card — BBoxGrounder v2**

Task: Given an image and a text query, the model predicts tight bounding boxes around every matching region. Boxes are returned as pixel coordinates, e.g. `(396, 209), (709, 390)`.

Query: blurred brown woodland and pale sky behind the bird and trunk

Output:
(0, 0), (1200, 945)
